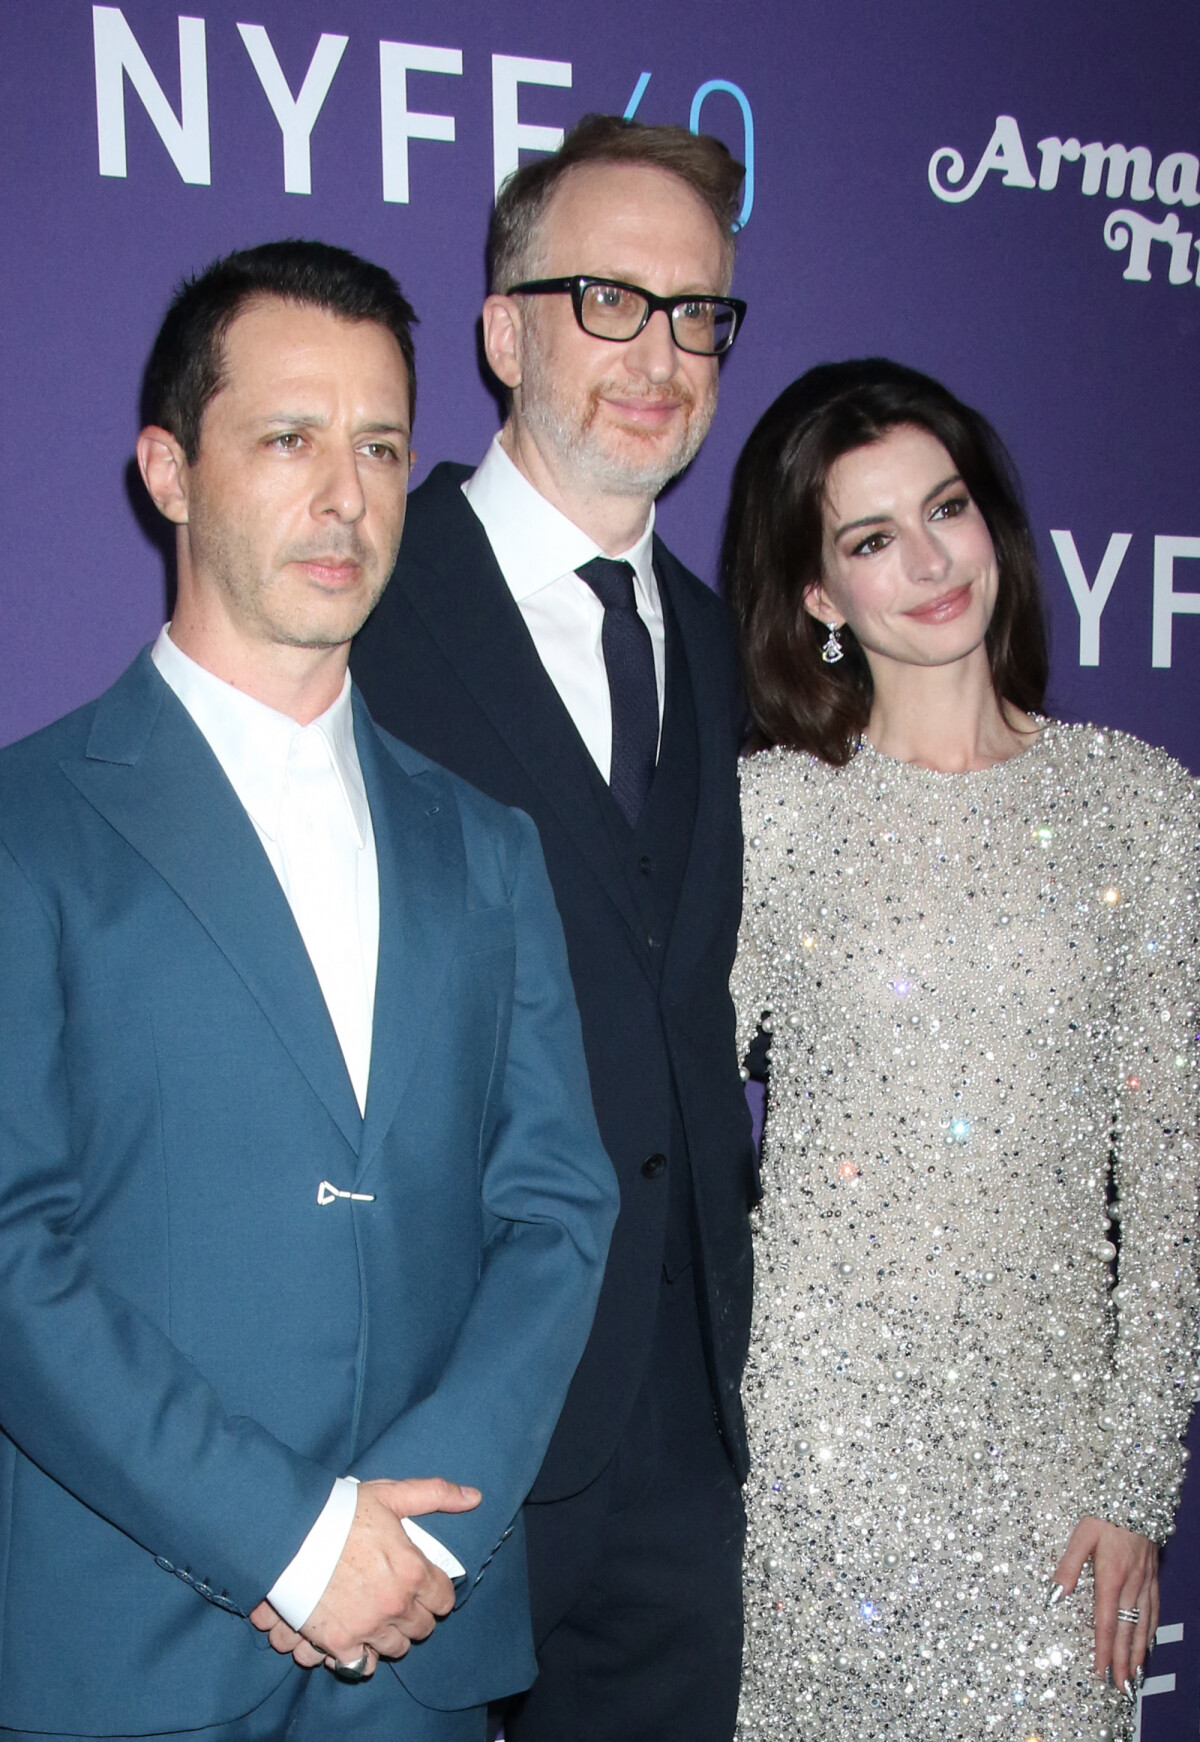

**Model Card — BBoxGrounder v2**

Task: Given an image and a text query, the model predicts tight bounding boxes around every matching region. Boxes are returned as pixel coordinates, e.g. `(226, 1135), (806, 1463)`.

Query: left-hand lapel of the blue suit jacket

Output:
(63, 652), (362, 1150)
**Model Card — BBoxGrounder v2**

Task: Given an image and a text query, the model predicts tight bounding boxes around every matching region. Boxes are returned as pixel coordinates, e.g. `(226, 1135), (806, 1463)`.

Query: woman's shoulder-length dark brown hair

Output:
(721, 357), (1048, 765)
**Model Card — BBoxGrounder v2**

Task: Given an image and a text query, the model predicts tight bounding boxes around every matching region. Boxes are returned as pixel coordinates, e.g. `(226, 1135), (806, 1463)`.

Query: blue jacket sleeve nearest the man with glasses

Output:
(341, 815), (618, 1603)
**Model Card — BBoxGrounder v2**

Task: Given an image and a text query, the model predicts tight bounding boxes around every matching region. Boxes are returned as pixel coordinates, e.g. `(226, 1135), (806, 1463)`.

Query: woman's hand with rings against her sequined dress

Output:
(1050, 1519), (1158, 1698)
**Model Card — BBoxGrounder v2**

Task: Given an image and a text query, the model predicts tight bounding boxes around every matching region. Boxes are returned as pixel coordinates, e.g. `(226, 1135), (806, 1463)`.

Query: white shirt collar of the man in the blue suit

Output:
(150, 624), (371, 848)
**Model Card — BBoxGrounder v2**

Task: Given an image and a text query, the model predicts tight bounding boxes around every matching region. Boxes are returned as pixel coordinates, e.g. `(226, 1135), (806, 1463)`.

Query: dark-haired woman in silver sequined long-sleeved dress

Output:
(725, 361), (1200, 1742)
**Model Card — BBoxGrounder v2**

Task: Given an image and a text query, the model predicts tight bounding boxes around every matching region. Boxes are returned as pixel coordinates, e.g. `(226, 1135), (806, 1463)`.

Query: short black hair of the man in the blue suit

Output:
(143, 240), (416, 463)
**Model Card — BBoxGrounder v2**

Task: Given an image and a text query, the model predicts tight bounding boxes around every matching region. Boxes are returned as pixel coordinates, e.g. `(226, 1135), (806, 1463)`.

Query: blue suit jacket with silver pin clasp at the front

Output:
(0, 653), (617, 1735)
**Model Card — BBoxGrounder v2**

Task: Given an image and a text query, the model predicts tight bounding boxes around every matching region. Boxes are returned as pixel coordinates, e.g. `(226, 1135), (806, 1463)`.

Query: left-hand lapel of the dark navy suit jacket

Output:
(400, 467), (643, 949)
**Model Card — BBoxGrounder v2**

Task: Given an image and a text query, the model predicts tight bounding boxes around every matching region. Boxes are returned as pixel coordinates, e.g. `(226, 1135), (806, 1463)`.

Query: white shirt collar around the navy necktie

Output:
(463, 436), (658, 608)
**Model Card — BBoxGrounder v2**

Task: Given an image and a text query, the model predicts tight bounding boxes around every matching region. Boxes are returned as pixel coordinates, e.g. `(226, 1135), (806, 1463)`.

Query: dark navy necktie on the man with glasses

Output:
(575, 556), (658, 827)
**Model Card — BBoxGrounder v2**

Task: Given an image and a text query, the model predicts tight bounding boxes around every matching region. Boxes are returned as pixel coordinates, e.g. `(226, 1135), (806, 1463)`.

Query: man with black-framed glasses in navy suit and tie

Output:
(352, 117), (754, 1742)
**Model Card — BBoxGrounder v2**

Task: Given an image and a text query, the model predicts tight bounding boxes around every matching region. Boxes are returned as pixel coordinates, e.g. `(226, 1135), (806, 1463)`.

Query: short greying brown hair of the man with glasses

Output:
(488, 115), (745, 294)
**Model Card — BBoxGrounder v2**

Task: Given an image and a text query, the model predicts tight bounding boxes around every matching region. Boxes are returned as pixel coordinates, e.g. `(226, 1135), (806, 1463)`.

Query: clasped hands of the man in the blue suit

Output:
(251, 1475), (482, 1676)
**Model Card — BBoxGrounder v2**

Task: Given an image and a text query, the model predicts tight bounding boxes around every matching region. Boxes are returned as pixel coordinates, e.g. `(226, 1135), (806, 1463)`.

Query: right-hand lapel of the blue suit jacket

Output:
(354, 692), (465, 1178)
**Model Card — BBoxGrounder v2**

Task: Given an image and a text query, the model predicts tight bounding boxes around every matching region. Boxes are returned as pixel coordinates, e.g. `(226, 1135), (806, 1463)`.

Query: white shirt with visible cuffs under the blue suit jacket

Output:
(150, 625), (463, 1629)
